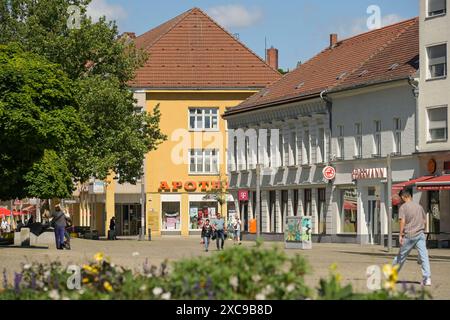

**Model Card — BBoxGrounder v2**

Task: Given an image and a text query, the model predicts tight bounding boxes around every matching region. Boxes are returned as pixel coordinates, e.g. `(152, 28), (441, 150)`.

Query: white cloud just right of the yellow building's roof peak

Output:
(208, 4), (263, 28)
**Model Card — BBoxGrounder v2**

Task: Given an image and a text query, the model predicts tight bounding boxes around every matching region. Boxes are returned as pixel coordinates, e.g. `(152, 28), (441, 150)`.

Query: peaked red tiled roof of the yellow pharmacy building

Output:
(130, 8), (281, 89)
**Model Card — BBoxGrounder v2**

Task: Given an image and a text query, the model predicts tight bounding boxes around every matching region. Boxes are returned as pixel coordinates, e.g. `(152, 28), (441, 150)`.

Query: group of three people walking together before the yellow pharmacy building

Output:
(201, 213), (242, 252)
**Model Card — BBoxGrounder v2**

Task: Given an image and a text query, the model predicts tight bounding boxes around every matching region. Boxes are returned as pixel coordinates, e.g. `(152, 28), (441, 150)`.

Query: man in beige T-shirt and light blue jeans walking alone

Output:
(393, 189), (431, 286)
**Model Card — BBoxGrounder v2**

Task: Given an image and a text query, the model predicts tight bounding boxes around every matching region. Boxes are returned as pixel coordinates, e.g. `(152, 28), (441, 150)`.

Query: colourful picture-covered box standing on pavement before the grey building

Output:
(285, 217), (312, 250)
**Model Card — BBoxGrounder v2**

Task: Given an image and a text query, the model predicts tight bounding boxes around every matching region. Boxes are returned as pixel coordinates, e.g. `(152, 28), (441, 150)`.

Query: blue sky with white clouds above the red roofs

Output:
(90, 0), (419, 69)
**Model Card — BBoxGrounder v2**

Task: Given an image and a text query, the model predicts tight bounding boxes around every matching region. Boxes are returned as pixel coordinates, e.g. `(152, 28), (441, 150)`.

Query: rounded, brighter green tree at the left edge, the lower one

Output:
(0, 45), (89, 200)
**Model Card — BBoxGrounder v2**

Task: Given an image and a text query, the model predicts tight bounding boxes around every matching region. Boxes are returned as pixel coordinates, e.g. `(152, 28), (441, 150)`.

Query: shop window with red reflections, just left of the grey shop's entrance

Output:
(341, 189), (358, 233)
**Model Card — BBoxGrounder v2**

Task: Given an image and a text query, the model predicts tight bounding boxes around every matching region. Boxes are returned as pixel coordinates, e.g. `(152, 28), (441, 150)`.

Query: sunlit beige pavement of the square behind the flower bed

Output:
(0, 237), (450, 300)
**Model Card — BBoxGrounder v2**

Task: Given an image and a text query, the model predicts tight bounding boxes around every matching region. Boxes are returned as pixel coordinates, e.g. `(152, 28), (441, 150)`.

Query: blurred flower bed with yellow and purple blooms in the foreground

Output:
(0, 245), (431, 300)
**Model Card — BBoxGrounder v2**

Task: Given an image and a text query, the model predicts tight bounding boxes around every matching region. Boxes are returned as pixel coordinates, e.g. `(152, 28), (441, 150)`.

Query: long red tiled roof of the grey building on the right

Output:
(225, 18), (419, 116)
